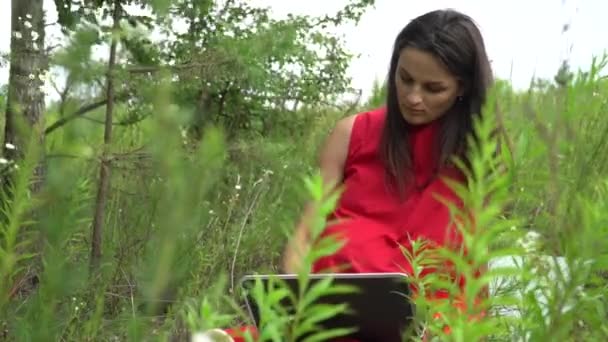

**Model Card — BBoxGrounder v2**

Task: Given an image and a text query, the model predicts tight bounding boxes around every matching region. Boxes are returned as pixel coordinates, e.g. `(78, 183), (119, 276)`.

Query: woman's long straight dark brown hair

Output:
(380, 9), (493, 193)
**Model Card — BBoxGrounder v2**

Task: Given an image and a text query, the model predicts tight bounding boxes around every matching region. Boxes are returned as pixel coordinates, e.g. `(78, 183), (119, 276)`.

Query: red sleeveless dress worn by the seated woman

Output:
(314, 108), (464, 280)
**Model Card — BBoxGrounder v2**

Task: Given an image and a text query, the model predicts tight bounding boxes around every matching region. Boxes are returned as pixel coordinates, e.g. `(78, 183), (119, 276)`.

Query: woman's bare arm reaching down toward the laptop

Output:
(282, 115), (355, 273)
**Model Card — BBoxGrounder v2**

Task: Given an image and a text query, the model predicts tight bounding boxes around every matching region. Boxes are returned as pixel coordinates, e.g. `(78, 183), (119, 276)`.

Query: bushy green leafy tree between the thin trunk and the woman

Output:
(159, 0), (374, 138)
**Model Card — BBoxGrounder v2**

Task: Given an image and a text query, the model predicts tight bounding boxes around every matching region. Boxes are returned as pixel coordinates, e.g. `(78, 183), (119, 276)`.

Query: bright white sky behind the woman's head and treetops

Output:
(0, 0), (608, 100)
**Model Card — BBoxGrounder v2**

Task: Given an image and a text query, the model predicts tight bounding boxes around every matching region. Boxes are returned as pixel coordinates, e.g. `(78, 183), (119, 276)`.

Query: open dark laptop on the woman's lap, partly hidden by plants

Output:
(241, 273), (414, 342)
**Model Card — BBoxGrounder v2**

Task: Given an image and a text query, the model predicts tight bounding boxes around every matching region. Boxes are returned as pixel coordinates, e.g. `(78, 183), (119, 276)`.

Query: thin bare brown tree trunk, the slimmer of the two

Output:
(90, 0), (121, 275)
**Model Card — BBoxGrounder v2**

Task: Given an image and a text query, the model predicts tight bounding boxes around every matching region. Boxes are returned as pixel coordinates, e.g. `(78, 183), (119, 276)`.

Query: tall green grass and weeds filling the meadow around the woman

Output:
(0, 52), (608, 341)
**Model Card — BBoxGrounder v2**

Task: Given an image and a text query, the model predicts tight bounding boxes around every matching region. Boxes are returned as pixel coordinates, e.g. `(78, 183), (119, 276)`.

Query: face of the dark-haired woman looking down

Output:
(395, 47), (463, 125)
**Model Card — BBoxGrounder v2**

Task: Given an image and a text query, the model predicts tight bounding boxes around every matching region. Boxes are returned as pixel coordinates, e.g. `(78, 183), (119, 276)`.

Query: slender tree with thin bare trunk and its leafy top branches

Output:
(47, 0), (164, 275)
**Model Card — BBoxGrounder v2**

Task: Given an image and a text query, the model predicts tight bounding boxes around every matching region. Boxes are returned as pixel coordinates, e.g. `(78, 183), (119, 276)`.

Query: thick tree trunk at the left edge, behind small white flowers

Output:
(2, 0), (48, 191)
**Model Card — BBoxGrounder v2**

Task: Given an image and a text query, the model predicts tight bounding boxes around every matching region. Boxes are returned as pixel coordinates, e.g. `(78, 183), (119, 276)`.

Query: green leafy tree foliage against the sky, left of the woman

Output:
(47, 0), (373, 139)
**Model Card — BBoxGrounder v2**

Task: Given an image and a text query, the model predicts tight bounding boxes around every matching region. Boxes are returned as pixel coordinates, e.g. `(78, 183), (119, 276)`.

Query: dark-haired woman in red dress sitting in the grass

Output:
(227, 10), (492, 342)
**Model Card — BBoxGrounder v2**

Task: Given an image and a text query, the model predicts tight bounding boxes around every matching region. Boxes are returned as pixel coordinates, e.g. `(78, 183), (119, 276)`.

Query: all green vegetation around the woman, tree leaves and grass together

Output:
(0, 0), (608, 341)
